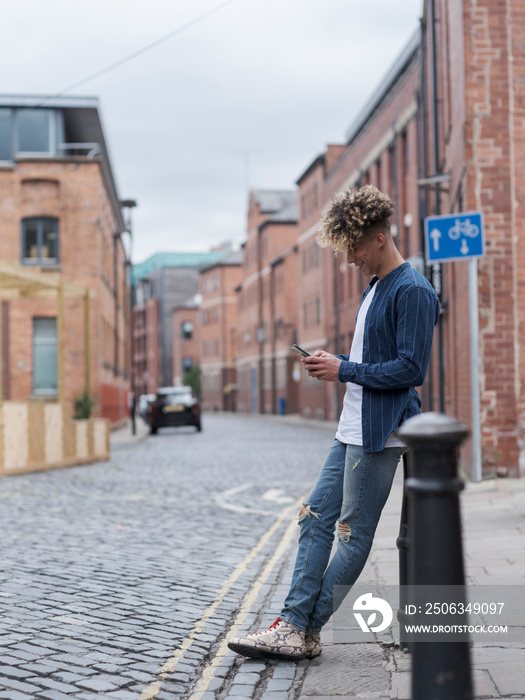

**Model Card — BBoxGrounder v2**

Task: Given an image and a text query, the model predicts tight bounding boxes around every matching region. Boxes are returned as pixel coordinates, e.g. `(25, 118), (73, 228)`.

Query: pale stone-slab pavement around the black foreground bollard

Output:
(300, 470), (525, 700)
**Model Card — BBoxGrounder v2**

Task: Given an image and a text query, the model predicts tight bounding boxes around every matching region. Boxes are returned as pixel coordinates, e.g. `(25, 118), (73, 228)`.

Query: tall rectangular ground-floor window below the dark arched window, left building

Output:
(33, 318), (58, 396)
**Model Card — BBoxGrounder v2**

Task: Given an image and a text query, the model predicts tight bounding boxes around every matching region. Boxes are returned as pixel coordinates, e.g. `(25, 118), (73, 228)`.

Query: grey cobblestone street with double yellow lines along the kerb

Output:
(0, 415), (331, 700)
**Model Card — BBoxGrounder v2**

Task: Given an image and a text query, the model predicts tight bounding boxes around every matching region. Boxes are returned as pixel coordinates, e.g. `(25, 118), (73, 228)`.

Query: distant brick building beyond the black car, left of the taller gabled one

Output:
(198, 252), (242, 411)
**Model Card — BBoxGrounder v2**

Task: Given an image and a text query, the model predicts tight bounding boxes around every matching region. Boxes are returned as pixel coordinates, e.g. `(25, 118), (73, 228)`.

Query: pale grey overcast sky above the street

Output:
(4, 0), (422, 262)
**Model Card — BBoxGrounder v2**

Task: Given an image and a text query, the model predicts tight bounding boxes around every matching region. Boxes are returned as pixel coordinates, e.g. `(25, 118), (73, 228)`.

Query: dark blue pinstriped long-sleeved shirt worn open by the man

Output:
(337, 262), (439, 452)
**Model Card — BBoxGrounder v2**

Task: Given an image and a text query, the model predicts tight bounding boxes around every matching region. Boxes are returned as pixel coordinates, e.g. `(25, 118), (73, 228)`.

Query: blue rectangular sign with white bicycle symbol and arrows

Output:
(425, 211), (485, 263)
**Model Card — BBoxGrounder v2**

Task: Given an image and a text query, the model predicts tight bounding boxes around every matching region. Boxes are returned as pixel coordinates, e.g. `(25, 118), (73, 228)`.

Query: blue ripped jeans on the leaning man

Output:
(281, 438), (406, 632)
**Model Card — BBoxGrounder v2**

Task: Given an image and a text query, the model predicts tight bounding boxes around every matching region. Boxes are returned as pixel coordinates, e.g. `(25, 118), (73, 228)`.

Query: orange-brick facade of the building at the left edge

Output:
(0, 159), (129, 420)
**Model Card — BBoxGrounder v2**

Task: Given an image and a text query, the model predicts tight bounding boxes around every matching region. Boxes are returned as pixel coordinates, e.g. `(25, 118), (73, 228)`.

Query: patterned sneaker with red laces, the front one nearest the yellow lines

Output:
(228, 617), (306, 661)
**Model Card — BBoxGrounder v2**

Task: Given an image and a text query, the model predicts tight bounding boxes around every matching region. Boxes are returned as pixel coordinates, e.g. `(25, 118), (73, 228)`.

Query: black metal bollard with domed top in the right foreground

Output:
(398, 413), (473, 700)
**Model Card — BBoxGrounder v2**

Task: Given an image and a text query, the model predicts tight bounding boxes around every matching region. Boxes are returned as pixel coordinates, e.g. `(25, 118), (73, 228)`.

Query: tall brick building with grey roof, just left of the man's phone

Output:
(237, 190), (297, 413)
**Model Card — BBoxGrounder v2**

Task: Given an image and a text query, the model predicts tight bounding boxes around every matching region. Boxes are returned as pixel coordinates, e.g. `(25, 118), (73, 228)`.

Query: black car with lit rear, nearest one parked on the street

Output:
(149, 386), (202, 435)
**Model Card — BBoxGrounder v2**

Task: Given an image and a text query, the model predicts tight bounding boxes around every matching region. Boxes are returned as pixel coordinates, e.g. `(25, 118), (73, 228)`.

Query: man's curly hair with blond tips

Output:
(316, 185), (395, 254)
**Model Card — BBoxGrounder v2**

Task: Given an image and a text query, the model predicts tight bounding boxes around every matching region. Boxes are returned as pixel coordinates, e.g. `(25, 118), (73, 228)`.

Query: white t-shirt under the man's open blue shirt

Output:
(335, 282), (405, 447)
